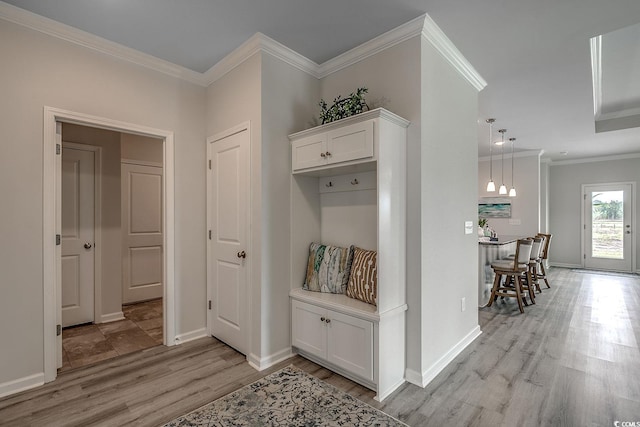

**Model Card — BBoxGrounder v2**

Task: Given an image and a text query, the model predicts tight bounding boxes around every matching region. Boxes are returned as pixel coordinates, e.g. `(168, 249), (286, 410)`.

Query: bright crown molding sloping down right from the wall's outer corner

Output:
(422, 15), (487, 91)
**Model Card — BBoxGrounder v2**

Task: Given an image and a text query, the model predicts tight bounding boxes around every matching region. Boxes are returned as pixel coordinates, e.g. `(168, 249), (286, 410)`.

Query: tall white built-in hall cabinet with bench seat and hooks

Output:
(289, 108), (409, 400)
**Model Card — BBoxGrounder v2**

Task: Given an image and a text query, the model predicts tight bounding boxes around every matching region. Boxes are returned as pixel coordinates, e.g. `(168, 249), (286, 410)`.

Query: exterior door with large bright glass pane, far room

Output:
(583, 183), (633, 272)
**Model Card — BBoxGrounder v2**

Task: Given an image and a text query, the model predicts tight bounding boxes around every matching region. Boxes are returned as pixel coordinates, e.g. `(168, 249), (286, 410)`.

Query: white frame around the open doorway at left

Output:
(42, 106), (176, 382)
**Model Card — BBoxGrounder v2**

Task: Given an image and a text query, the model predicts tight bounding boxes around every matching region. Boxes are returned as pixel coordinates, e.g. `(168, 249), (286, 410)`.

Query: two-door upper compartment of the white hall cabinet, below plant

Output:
(291, 119), (375, 173)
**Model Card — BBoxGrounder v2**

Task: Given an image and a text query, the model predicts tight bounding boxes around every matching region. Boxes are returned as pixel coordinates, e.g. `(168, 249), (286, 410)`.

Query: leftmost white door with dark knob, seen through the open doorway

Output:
(61, 145), (95, 326)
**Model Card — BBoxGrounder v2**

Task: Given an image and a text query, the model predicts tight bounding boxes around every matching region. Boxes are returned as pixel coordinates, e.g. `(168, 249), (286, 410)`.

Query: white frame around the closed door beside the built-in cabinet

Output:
(206, 121), (254, 360)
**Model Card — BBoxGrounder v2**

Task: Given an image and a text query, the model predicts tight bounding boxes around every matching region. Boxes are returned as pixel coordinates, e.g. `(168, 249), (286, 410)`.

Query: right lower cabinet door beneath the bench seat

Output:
(327, 311), (373, 381)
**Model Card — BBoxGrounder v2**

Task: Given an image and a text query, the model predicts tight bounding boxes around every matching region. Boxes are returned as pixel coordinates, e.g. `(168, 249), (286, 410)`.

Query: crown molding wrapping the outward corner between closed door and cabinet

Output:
(204, 33), (319, 86)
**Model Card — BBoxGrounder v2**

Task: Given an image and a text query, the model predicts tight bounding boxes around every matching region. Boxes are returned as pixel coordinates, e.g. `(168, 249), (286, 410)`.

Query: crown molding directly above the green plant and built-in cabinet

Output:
(318, 15), (427, 78)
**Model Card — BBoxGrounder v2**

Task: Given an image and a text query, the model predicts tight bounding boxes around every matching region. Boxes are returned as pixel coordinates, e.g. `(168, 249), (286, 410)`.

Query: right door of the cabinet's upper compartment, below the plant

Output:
(327, 120), (373, 163)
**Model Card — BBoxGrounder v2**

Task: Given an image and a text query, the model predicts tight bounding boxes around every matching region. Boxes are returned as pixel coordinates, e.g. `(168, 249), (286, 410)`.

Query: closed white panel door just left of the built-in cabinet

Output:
(207, 127), (250, 355)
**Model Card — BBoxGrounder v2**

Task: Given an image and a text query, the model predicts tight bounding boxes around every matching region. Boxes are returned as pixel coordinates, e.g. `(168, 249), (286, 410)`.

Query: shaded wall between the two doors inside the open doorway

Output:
(62, 123), (122, 323)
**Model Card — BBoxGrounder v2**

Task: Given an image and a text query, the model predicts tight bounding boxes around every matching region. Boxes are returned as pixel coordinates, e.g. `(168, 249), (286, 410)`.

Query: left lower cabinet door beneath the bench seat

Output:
(291, 300), (327, 359)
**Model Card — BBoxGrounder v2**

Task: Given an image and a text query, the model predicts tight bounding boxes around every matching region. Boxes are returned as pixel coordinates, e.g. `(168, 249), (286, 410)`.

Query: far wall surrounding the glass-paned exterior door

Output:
(549, 157), (640, 268)
